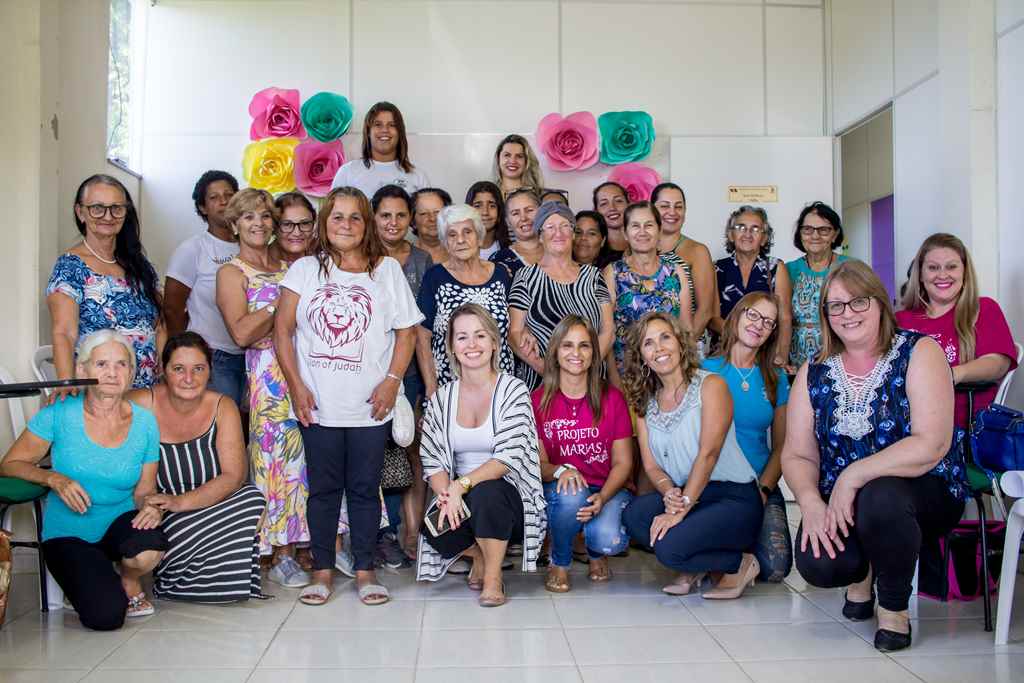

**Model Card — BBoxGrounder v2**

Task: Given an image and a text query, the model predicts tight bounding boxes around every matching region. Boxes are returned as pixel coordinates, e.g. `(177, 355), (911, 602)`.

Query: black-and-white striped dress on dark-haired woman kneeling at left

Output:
(153, 419), (266, 602)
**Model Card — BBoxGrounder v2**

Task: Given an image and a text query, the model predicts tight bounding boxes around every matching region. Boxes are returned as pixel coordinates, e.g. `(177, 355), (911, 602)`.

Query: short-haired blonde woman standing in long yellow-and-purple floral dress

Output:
(217, 187), (309, 588)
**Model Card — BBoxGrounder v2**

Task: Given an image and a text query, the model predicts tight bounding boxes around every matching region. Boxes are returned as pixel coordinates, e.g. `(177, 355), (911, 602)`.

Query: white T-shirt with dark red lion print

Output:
(281, 256), (423, 427)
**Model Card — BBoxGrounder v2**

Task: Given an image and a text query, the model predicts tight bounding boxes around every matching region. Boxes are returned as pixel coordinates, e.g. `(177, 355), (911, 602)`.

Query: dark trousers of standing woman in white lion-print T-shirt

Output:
(299, 421), (391, 570)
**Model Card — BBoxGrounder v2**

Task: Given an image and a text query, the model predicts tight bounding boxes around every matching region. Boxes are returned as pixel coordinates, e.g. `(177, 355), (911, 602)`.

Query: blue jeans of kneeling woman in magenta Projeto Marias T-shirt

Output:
(544, 481), (633, 567)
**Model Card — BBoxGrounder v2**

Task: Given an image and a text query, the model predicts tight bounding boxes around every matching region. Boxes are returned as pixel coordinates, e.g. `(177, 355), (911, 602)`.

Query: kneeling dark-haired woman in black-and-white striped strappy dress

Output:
(129, 332), (266, 602)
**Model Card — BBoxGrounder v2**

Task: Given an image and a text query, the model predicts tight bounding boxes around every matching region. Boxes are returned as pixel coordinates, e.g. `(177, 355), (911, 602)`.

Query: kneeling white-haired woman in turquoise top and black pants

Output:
(0, 330), (167, 631)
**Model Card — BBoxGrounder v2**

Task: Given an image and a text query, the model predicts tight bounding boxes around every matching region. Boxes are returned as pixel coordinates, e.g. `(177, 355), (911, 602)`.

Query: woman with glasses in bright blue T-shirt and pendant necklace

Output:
(702, 292), (793, 584)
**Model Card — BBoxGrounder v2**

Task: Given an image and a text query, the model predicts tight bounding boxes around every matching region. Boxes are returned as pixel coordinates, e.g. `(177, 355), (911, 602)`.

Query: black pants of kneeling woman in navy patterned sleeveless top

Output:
(796, 474), (964, 611)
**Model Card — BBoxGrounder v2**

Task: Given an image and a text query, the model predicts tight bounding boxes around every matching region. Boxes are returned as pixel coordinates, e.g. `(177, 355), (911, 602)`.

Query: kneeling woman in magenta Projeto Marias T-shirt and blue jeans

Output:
(534, 315), (633, 593)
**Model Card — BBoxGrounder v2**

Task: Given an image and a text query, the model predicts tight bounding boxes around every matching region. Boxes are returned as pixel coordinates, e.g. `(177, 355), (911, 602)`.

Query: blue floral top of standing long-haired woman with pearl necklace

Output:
(46, 254), (158, 388)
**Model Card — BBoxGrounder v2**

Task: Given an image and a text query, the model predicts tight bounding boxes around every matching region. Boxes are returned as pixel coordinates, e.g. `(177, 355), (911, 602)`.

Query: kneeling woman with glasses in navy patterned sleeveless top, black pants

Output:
(782, 259), (966, 652)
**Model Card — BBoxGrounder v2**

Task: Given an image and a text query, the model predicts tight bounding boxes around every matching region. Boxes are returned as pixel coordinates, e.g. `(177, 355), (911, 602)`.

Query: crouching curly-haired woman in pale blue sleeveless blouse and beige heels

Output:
(623, 312), (764, 598)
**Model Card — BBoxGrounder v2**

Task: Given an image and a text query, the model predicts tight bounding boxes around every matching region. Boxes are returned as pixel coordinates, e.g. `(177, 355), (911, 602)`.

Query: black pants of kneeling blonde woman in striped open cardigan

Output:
(423, 479), (523, 559)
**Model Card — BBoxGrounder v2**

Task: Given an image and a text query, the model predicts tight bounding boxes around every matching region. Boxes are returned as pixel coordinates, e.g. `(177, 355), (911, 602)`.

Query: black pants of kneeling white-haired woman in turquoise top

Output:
(40, 510), (168, 631)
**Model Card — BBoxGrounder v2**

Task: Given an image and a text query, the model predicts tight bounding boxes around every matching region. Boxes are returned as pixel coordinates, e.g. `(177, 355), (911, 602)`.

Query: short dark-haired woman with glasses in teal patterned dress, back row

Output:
(780, 202), (847, 370)
